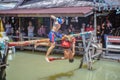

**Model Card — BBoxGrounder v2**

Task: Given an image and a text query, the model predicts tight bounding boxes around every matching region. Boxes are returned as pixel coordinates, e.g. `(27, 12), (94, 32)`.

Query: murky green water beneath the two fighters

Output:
(7, 51), (120, 80)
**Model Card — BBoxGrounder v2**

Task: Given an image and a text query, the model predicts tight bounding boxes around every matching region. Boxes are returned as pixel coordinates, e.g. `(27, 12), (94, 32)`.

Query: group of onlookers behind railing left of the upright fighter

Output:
(5, 21), (47, 37)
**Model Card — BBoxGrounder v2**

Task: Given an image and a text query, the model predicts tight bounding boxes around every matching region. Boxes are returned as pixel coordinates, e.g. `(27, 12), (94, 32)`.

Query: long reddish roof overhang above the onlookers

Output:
(0, 7), (93, 17)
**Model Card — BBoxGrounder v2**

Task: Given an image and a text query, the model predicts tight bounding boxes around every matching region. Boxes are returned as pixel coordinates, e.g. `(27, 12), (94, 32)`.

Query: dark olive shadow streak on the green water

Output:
(39, 69), (78, 80)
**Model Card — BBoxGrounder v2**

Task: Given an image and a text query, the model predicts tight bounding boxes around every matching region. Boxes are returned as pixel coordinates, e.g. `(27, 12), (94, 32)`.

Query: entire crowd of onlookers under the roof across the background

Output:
(5, 20), (113, 47)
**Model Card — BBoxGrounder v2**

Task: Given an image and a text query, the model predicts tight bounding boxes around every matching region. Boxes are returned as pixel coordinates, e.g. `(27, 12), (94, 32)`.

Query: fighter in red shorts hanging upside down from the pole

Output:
(49, 36), (76, 62)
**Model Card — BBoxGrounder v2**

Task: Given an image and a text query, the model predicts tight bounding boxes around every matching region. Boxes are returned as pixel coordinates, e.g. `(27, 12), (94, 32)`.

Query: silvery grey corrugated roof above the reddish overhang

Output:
(18, 0), (105, 8)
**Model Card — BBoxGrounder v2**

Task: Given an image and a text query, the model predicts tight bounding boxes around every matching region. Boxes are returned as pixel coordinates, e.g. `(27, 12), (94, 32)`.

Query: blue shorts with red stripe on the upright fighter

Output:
(48, 31), (63, 42)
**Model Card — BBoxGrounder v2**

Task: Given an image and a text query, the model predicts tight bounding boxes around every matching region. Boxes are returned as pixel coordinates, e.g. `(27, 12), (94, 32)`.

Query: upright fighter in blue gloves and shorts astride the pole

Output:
(35, 15), (64, 62)
